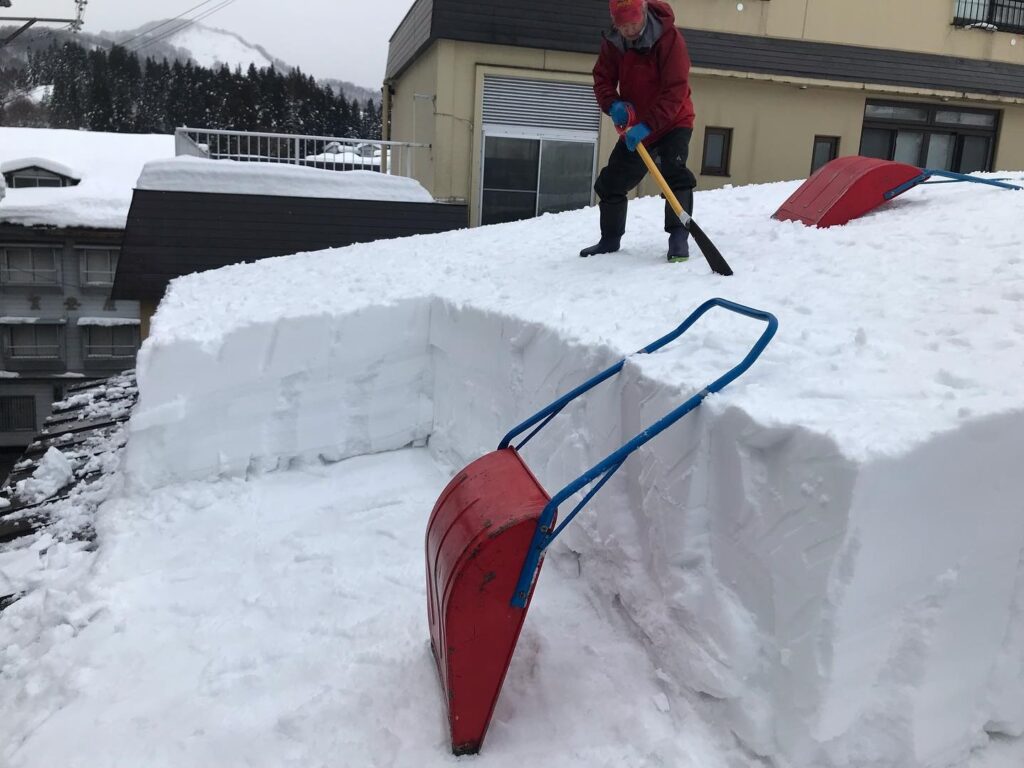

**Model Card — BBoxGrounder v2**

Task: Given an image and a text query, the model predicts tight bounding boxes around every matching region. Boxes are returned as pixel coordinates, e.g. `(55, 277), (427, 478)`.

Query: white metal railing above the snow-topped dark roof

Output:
(174, 128), (430, 176)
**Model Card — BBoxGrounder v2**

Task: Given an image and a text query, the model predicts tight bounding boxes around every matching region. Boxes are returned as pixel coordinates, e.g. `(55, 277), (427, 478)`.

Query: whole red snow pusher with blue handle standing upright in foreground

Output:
(426, 299), (778, 755)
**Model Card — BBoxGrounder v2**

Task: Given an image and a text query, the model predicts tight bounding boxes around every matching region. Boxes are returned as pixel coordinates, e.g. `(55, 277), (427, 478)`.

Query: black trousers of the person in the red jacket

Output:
(594, 128), (697, 238)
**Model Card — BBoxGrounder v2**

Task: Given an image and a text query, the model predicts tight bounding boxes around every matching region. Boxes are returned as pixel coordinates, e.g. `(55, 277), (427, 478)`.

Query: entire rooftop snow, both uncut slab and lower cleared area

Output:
(0, 169), (1024, 768)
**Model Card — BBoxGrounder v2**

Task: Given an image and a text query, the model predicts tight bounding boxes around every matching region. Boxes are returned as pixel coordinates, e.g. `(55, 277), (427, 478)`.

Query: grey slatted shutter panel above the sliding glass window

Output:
(483, 75), (601, 135)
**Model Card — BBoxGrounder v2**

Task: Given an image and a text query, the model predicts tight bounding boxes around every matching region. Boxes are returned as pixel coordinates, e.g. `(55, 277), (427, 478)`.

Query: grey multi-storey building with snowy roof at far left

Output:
(0, 128), (173, 456)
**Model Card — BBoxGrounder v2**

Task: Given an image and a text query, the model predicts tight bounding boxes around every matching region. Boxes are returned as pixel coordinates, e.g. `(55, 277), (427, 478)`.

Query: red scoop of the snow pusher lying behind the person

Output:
(772, 156), (923, 227)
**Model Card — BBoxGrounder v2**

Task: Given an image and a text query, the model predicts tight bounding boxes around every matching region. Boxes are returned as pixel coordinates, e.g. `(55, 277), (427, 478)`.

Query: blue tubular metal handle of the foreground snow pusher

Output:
(507, 299), (778, 608)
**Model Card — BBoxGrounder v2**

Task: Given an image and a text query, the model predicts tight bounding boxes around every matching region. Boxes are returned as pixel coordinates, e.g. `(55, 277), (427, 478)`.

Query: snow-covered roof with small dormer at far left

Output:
(0, 127), (174, 229)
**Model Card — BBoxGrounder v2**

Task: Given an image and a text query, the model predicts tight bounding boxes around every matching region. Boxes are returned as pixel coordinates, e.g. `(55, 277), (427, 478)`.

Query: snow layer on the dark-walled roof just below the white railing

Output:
(136, 157), (433, 203)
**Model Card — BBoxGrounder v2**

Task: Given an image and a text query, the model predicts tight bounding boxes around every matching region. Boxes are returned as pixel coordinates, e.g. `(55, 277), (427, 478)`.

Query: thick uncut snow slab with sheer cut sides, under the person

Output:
(126, 174), (1024, 768)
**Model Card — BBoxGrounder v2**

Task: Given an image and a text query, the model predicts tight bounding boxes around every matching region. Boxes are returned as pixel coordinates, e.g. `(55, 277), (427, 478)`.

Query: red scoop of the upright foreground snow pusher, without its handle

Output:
(426, 449), (550, 755)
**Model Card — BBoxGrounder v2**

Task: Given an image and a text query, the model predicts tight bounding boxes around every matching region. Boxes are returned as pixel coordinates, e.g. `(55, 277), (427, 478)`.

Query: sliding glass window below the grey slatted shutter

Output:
(480, 135), (595, 224)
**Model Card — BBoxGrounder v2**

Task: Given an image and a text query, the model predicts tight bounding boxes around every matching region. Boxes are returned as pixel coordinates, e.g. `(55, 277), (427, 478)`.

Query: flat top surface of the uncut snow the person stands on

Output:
(147, 173), (1024, 457)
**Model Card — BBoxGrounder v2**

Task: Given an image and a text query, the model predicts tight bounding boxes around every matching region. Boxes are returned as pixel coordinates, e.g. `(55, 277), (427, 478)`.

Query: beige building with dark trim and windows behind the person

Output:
(384, 0), (1024, 224)
